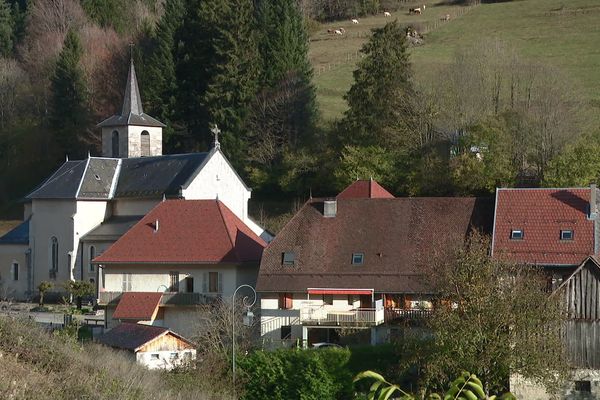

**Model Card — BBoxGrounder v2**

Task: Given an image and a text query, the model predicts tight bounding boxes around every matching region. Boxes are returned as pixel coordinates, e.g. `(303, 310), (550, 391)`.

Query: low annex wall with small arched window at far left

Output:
(0, 244), (29, 300)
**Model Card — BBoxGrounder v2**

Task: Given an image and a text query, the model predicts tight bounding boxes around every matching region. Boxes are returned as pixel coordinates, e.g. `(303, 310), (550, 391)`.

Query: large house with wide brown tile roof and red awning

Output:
(257, 181), (493, 346)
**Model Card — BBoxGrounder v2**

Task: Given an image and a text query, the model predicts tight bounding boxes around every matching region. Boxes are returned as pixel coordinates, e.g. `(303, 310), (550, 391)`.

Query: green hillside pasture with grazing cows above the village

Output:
(310, 0), (600, 121)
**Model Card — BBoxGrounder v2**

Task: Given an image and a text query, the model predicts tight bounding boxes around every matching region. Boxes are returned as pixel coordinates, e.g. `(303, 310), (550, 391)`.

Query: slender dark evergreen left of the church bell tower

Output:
(50, 30), (90, 156)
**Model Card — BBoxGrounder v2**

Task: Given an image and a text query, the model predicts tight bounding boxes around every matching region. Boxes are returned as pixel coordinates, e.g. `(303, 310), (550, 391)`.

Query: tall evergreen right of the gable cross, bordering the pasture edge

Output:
(248, 0), (317, 192)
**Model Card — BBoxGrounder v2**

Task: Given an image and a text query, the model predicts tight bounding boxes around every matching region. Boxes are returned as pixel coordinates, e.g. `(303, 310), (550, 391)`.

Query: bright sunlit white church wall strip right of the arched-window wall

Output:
(71, 201), (109, 279)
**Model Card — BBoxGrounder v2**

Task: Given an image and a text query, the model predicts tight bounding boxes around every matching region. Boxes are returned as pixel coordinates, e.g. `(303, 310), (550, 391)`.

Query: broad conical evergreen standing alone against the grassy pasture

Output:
(339, 21), (417, 150)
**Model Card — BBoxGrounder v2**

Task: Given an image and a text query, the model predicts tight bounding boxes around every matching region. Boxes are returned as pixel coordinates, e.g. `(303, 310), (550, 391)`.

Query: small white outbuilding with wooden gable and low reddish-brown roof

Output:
(98, 322), (196, 369)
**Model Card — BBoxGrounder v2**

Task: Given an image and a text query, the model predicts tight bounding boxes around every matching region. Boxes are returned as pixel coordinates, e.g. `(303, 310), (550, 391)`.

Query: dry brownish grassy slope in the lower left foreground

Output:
(0, 317), (216, 400)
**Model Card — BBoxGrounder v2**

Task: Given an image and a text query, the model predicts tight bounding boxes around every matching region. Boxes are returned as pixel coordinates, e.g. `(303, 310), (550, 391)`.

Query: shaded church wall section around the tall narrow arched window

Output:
(29, 199), (77, 291)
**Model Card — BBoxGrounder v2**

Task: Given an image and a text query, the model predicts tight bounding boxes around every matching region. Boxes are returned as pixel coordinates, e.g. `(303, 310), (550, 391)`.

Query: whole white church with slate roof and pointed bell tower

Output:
(0, 60), (271, 300)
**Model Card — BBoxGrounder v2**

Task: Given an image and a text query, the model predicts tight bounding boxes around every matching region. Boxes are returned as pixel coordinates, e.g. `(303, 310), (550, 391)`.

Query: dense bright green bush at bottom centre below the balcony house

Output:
(238, 349), (352, 400)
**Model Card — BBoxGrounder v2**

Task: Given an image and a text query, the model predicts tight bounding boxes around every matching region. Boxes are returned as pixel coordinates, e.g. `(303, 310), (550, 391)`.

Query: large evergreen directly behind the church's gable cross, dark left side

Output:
(176, 0), (259, 166)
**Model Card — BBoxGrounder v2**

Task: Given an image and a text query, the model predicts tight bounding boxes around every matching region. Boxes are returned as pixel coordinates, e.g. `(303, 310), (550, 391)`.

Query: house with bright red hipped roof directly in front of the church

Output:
(94, 200), (266, 336)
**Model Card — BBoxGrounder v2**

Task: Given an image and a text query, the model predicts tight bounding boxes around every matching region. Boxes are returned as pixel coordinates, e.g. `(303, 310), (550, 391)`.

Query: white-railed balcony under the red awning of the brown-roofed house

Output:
(300, 303), (384, 327)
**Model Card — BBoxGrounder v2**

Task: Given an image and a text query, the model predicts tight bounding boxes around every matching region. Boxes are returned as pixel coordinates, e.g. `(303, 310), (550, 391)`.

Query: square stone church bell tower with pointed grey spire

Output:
(98, 58), (165, 158)
